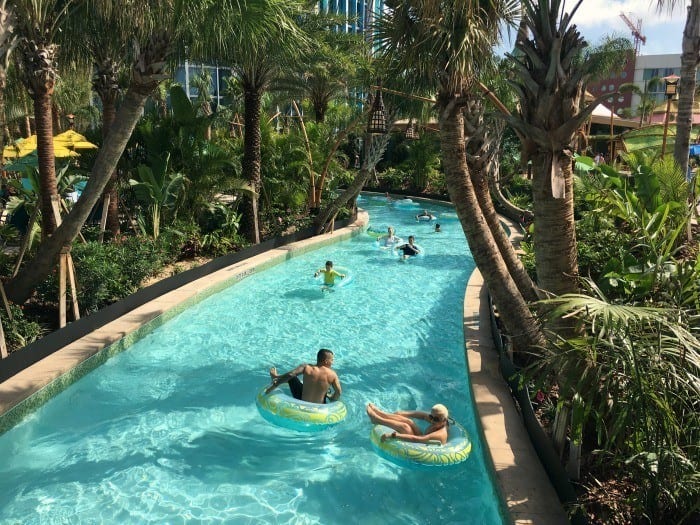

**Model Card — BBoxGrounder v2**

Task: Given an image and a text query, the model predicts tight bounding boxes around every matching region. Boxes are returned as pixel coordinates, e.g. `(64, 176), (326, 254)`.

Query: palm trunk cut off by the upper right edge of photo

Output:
(673, 0), (700, 175)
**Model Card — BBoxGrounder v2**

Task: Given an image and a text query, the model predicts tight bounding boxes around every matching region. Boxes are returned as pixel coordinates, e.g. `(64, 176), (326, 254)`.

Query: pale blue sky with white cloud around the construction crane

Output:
(499, 0), (687, 55)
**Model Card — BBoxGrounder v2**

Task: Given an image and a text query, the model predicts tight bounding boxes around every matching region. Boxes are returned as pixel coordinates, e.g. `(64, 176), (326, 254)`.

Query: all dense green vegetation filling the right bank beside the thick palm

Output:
(512, 155), (700, 523)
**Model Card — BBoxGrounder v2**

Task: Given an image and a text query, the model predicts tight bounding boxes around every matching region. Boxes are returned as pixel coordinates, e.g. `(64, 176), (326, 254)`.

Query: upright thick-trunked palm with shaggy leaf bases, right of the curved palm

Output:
(506, 0), (629, 295)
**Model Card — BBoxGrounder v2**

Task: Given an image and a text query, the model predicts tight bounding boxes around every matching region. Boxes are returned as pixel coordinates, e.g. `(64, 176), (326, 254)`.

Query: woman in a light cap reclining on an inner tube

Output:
(367, 403), (450, 445)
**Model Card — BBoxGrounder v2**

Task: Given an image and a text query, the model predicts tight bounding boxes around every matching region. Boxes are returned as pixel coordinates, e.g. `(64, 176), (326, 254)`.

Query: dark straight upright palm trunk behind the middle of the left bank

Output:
(241, 81), (262, 244)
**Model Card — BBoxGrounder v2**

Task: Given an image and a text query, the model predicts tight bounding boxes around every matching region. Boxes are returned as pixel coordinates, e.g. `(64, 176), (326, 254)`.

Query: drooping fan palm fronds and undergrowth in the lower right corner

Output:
(530, 283), (700, 523)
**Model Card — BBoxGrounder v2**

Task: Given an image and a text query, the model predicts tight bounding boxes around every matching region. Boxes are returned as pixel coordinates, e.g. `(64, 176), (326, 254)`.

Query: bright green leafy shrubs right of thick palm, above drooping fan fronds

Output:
(577, 156), (690, 301)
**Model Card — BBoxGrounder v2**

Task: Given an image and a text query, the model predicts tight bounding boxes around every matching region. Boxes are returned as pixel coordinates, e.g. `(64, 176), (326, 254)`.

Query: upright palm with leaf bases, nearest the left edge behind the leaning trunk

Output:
(14, 0), (71, 237)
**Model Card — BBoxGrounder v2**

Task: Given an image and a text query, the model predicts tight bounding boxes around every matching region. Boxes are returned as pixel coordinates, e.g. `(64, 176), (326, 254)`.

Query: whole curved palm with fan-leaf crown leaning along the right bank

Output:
(377, 0), (544, 350)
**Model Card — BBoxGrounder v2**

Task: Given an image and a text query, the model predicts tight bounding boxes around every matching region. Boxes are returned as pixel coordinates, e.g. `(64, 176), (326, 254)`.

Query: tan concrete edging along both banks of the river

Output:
(0, 213), (568, 525)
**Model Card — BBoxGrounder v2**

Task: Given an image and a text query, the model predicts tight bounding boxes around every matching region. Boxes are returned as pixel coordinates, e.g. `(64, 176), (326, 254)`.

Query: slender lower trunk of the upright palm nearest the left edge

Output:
(34, 92), (58, 239)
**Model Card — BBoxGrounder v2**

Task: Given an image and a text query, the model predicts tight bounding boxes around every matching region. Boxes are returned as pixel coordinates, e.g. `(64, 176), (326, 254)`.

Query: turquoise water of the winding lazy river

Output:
(0, 197), (503, 525)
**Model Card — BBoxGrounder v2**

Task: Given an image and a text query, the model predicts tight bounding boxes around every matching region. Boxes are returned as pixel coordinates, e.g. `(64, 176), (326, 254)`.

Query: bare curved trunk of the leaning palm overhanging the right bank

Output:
(440, 100), (545, 351)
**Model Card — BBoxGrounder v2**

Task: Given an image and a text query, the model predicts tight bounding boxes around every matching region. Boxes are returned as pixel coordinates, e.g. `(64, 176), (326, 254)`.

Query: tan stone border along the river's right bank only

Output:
(464, 218), (569, 525)
